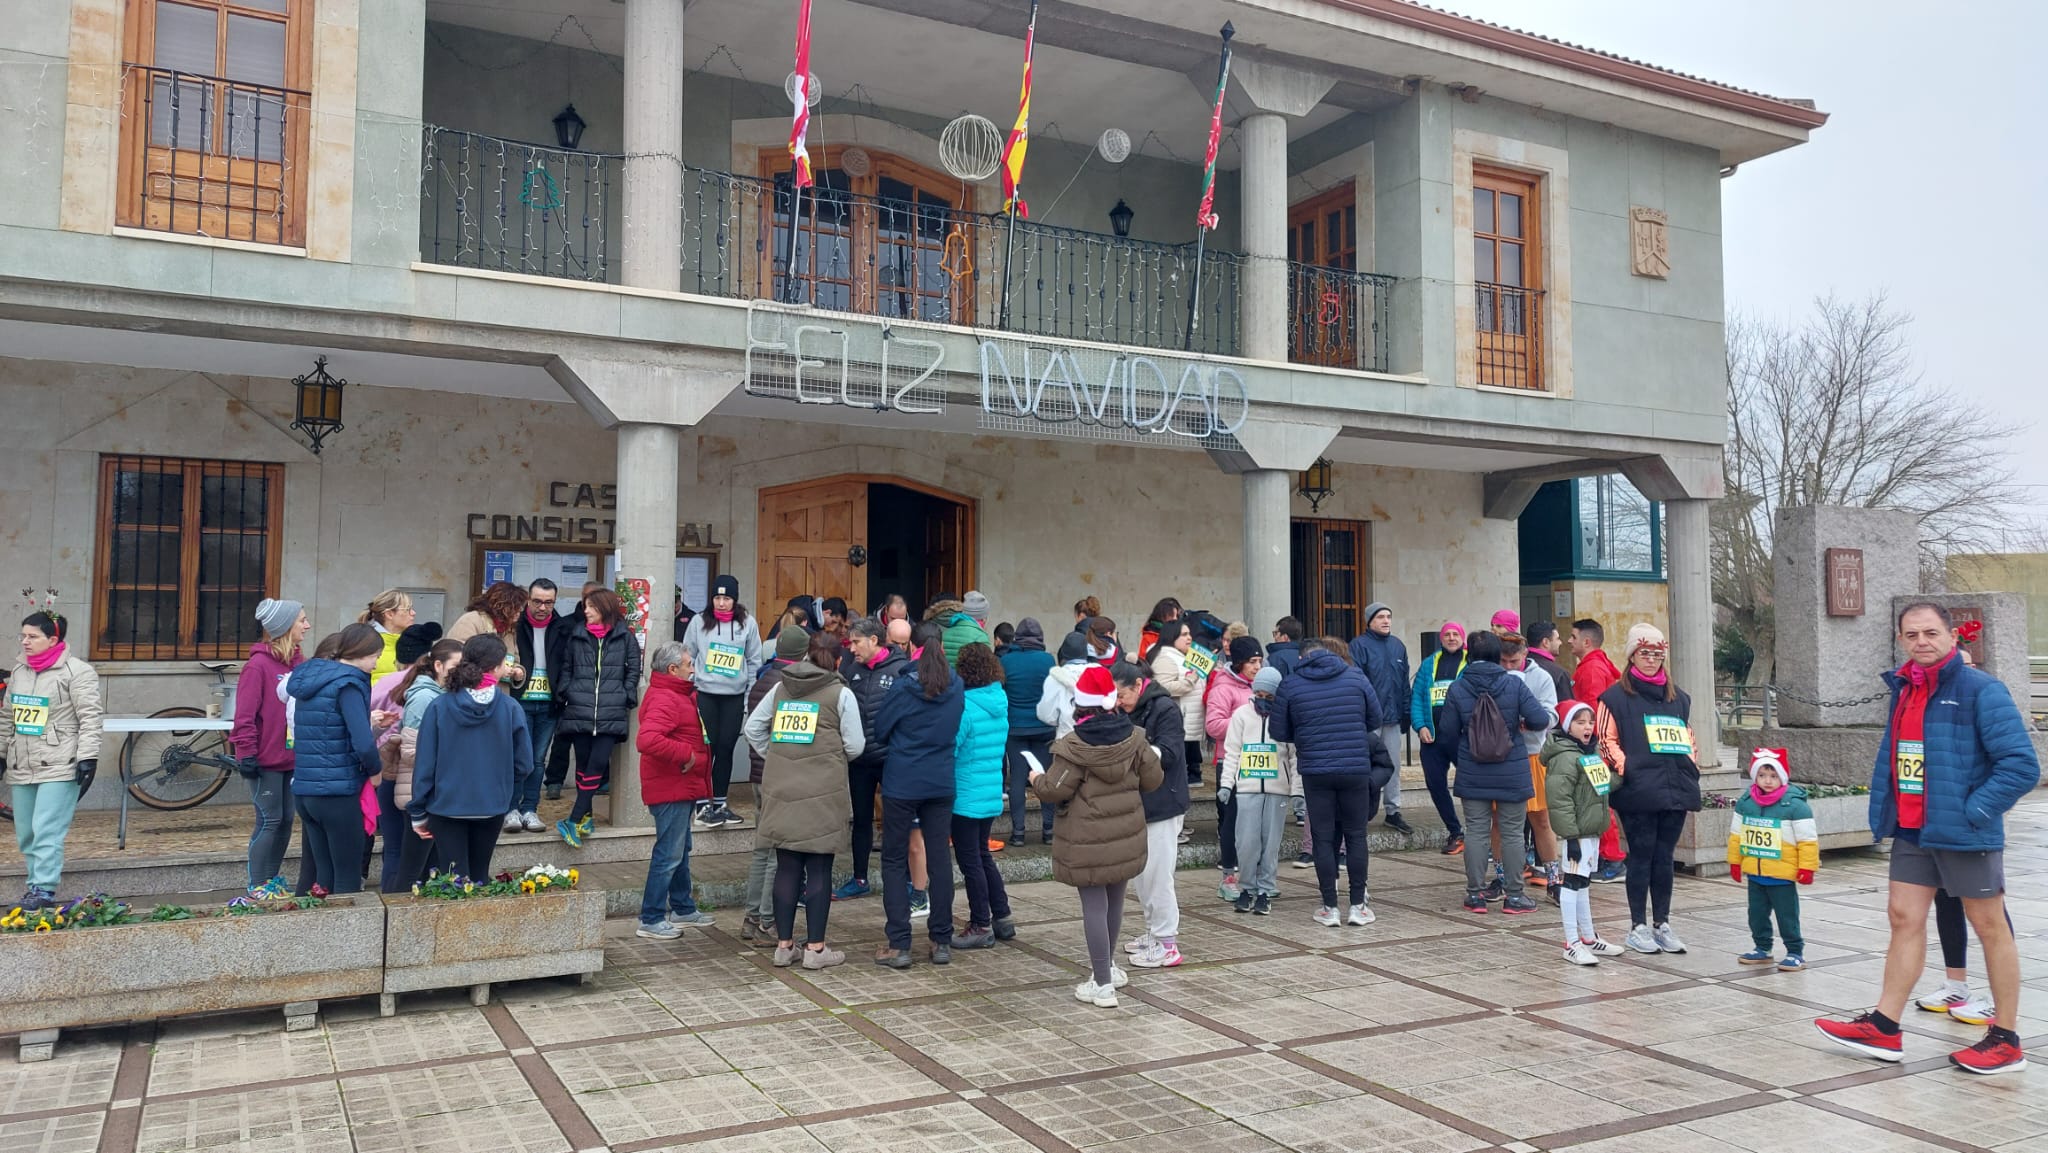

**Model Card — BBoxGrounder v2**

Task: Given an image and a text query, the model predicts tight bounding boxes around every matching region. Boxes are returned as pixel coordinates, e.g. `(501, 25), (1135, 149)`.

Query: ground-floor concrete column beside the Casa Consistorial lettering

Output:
(612, 424), (682, 827)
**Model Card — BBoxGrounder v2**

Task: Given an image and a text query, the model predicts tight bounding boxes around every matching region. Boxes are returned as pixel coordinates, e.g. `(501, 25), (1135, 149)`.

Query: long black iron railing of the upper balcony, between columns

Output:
(420, 127), (1395, 371)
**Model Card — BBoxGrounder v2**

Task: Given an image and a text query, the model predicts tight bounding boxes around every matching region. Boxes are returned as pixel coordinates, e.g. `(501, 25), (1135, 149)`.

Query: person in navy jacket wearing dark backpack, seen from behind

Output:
(1436, 631), (1552, 913)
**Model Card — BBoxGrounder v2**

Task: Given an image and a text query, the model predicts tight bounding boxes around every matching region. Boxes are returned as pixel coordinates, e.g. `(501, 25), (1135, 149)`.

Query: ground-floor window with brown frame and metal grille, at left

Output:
(92, 457), (285, 661)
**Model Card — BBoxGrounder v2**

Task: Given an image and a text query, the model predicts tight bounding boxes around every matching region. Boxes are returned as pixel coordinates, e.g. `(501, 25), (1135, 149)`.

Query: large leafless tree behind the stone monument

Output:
(1712, 293), (2023, 684)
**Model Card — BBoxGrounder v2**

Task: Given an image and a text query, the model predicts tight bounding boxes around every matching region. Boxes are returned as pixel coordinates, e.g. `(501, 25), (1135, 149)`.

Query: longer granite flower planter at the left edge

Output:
(0, 897), (385, 1061)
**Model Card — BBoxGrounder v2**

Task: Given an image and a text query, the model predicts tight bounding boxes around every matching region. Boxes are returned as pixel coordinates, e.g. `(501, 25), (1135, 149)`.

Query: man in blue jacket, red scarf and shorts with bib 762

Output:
(1815, 602), (2042, 1073)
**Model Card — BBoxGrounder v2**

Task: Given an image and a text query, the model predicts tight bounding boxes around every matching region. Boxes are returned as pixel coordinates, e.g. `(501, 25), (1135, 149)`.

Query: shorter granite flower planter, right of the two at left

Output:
(379, 889), (604, 1016)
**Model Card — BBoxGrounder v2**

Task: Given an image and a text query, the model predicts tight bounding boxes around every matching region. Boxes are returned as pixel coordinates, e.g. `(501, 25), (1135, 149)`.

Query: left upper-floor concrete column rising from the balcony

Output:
(614, 0), (684, 288)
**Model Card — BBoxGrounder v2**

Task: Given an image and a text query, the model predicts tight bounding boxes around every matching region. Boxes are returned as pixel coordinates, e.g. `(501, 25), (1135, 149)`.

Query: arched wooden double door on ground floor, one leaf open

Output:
(756, 475), (975, 618)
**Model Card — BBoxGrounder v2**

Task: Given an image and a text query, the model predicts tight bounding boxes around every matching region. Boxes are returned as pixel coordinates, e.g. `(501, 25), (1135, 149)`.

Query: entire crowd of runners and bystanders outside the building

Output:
(6, 589), (2040, 1073)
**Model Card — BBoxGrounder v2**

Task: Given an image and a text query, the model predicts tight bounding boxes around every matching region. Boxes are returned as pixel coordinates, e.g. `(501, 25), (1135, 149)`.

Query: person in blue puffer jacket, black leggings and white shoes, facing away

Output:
(1272, 641), (1384, 928)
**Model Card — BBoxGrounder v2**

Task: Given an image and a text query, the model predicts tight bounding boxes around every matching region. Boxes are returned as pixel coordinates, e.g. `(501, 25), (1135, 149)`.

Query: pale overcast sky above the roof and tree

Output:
(1434, 0), (2048, 497)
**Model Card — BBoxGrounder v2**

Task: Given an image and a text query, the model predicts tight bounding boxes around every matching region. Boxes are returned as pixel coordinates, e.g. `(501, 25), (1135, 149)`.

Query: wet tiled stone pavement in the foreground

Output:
(12, 795), (2048, 1153)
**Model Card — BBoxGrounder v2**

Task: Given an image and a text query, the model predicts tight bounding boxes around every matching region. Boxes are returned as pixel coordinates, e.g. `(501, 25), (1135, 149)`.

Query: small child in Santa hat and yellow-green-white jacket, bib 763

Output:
(1729, 750), (1821, 973)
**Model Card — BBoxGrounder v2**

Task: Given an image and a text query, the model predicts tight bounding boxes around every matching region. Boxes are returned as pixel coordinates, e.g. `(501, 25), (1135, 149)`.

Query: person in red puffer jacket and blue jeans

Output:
(633, 641), (715, 940)
